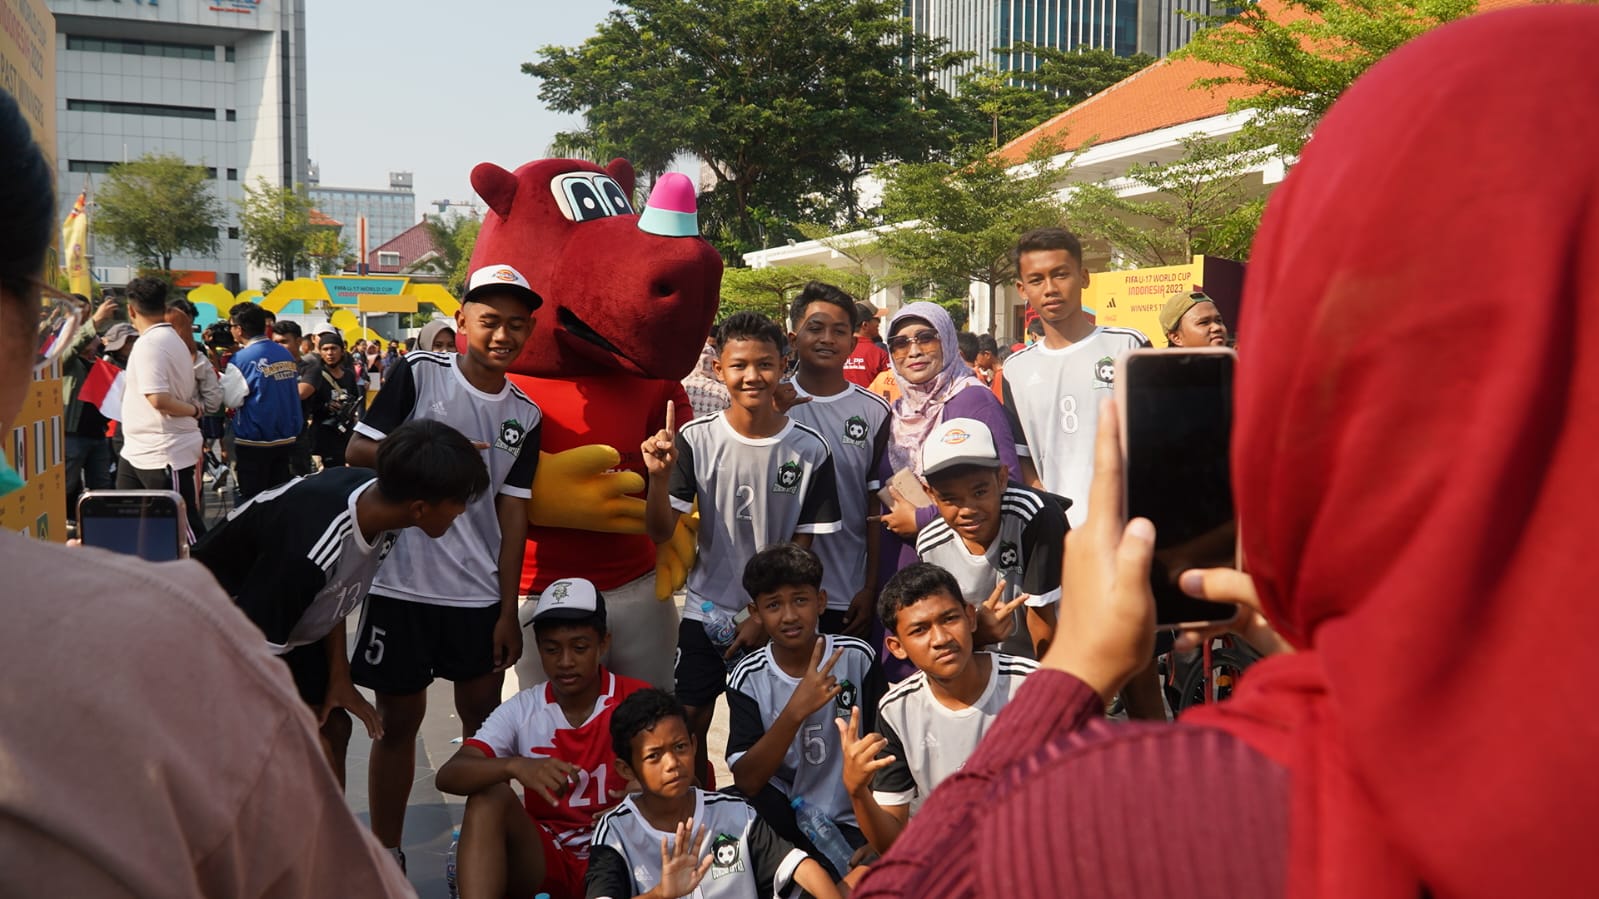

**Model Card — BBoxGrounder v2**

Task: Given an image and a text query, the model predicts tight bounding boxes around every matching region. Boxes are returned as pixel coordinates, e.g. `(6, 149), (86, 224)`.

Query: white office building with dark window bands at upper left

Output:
(50, 0), (309, 293)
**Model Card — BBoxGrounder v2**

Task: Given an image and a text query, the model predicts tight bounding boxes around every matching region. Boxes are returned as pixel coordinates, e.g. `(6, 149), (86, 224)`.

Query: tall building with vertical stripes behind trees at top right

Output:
(905, 0), (1144, 93)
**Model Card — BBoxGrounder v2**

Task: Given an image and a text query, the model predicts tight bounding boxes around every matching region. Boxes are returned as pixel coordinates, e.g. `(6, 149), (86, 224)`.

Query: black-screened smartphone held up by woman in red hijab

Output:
(1116, 347), (1238, 627)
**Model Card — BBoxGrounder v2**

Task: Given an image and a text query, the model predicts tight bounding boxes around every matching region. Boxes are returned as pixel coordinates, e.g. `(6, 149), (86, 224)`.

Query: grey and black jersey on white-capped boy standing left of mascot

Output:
(355, 352), (544, 606)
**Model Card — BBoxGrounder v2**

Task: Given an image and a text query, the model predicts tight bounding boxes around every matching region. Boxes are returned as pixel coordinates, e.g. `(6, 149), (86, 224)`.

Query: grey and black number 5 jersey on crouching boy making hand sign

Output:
(728, 635), (883, 827)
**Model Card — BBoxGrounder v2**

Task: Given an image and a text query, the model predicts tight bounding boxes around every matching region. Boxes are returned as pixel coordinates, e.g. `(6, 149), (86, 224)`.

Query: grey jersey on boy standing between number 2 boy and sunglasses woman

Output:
(788, 384), (892, 611)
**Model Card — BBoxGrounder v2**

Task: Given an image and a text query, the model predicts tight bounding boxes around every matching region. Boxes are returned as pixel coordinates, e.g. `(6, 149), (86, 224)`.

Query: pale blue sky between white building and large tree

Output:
(305, 0), (612, 216)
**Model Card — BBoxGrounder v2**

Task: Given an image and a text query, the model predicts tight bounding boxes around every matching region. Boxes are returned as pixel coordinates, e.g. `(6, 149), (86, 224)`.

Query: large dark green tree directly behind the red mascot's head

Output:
(523, 0), (955, 256)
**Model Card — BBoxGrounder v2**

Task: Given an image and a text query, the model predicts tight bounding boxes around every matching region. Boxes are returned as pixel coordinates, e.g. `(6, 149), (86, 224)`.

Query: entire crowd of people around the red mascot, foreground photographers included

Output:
(0, 6), (1599, 899)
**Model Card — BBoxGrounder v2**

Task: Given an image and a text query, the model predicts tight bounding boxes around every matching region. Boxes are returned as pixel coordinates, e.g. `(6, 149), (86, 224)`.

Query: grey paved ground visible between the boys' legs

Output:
(347, 597), (732, 899)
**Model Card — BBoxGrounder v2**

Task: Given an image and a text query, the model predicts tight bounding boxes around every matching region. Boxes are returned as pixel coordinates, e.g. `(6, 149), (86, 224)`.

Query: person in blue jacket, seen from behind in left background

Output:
(224, 302), (305, 502)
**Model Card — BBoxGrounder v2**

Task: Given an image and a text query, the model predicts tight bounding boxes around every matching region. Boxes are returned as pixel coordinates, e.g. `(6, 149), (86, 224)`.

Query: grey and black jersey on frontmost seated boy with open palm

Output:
(584, 789), (809, 899)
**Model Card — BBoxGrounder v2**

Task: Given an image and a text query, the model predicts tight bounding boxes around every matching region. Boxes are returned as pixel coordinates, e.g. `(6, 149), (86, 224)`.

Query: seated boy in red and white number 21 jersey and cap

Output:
(437, 577), (649, 899)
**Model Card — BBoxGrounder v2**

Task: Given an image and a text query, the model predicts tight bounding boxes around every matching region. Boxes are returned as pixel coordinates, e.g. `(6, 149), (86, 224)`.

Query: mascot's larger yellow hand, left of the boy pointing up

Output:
(528, 443), (644, 534)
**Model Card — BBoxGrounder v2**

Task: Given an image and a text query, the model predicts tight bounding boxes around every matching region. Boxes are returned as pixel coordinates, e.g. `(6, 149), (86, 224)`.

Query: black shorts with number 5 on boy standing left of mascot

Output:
(350, 593), (500, 696)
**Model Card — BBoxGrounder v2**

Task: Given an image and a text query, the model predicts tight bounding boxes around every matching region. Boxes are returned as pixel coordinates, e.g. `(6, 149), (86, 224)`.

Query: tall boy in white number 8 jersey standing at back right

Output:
(1004, 227), (1150, 526)
